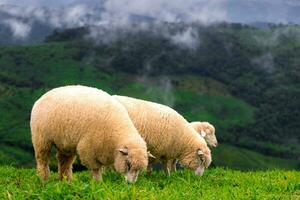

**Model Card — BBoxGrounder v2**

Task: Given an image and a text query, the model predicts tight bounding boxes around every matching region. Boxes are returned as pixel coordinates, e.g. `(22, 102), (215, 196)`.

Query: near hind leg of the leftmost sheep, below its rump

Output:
(34, 143), (51, 180)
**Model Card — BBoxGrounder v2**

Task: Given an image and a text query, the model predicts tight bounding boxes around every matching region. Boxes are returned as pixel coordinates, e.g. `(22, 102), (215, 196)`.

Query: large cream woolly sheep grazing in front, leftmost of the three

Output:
(30, 85), (148, 183)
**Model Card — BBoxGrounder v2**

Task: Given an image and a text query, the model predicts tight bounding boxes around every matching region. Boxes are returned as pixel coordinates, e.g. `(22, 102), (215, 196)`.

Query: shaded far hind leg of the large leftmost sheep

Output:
(56, 151), (76, 181)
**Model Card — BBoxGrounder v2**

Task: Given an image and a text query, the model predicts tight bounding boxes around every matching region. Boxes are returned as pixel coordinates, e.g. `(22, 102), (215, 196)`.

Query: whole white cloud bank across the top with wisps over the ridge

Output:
(0, 0), (298, 43)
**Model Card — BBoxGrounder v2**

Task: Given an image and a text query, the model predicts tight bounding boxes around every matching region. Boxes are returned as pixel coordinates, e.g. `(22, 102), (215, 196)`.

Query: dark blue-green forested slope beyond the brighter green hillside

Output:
(48, 23), (300, 159)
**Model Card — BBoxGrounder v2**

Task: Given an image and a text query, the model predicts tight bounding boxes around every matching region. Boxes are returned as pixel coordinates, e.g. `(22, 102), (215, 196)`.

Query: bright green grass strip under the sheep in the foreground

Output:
(0, 167), (300, 200)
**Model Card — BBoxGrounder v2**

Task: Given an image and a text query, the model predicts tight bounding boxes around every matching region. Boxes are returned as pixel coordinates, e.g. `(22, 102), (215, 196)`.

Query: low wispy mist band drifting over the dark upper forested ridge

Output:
(86, 21), (201, 50)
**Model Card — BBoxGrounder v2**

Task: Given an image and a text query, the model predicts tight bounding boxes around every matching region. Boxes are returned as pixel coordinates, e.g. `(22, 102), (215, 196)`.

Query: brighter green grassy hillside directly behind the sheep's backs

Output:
(0, 43), (254, 166)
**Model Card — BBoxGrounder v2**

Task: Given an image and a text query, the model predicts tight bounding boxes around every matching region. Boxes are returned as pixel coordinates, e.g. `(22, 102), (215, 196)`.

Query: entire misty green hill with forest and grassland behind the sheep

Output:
(0, 23), (300, 169)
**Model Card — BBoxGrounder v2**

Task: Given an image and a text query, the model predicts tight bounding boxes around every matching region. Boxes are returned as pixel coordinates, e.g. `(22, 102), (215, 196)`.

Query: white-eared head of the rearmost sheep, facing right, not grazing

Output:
(190, 122), (218, 147)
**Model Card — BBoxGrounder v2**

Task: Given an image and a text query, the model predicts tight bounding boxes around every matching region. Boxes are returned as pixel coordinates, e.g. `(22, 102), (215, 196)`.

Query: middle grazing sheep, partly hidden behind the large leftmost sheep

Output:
(113, 95), (211, 176)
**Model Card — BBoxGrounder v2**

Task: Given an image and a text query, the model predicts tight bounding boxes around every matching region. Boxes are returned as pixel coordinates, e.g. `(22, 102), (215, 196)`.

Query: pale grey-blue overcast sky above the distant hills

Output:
(0, 0), (300, 24)
